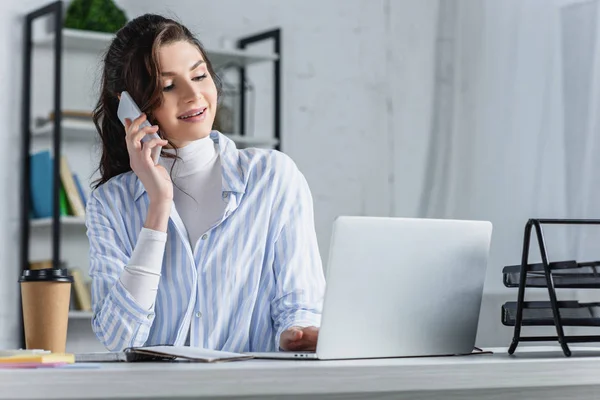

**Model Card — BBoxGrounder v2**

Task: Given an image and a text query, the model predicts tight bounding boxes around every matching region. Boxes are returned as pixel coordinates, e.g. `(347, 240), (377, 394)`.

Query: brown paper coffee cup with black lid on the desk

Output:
(19, 268), (73, 353)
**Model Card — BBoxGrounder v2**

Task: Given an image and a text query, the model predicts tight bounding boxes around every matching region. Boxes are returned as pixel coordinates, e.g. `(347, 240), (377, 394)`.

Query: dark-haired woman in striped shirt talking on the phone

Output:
(86, 14), (325, 352)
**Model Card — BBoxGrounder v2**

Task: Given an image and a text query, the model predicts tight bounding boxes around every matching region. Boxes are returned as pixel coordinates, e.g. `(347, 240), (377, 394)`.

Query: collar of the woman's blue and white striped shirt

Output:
(134, 131), (247, 201)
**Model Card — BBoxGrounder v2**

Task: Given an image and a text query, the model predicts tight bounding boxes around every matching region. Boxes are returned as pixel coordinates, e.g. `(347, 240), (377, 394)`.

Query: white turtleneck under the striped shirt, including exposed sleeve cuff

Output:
(120, 136), (225, 309)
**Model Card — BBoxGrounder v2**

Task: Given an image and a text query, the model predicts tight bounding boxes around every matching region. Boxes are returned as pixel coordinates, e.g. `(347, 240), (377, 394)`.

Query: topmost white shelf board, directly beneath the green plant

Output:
(34, 28), (278, 68)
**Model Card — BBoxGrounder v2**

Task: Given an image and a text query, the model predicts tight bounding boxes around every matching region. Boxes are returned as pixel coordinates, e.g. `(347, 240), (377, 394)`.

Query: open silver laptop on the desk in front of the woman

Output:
(249, 216), (492, 360)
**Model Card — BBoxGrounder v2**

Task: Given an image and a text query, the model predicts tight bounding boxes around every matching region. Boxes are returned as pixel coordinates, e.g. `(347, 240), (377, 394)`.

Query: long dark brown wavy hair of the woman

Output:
(92, 14), (221, 188)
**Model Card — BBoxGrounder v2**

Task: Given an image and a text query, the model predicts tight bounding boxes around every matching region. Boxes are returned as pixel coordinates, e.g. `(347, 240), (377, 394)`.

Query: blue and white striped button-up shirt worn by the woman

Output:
(86, 131), (325, 352)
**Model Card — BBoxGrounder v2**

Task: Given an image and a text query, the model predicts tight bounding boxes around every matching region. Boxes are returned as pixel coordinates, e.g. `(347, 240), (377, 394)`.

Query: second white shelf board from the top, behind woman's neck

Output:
(31, 118), (278, 148)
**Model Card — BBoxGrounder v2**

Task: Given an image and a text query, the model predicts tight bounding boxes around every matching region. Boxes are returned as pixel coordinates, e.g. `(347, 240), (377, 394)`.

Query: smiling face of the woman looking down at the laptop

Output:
(152, 41), (217, 148)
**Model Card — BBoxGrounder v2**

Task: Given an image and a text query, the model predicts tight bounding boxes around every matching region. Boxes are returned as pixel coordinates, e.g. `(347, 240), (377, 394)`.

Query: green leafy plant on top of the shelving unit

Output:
(65, 0), (127, 33)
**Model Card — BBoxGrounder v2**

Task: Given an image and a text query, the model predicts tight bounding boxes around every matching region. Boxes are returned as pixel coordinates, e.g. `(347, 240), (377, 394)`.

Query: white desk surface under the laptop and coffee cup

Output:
(0, 349), (600, 400)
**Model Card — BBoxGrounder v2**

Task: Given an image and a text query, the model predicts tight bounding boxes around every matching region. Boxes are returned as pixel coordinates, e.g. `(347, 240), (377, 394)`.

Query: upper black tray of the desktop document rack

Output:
(502, 261), (600, 289)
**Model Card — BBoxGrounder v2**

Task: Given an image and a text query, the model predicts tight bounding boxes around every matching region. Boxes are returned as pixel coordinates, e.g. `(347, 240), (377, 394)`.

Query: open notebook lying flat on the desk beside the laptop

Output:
(75, 345), (254, 363)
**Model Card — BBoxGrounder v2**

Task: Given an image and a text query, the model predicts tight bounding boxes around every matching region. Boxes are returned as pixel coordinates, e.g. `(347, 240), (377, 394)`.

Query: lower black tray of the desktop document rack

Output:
(502, 301), (600, 326)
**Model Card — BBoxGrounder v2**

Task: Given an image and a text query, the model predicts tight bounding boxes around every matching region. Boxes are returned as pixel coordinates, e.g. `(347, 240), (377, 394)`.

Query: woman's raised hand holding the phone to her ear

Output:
(125, 113), (173, 204)
